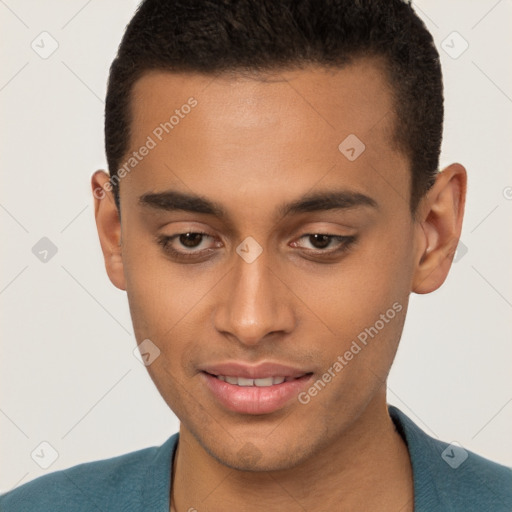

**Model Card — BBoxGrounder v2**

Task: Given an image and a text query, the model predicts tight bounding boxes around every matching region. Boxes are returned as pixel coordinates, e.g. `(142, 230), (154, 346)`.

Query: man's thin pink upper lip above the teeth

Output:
(200, 361), (311, 379)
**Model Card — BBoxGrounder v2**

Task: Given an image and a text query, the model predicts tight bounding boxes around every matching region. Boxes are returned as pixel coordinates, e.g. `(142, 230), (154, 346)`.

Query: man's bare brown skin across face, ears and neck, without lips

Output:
(92, 60), (466, 512)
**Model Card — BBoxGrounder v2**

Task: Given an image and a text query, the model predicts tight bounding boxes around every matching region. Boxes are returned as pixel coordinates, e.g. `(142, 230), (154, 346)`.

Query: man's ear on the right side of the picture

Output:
(412, 164), (467, 293)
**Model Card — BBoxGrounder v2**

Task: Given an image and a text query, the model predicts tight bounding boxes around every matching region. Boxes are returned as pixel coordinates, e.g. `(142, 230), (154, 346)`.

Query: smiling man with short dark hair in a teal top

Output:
(0, 0), (512, 512)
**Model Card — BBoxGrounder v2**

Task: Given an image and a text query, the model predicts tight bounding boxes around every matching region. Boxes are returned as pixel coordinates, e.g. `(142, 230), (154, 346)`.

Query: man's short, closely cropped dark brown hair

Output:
(105, 0), (443, 212)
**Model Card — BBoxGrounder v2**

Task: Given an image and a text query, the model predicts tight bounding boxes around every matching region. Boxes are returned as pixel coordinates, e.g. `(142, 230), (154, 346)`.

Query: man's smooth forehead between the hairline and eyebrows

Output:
(123, 59), (408, 216)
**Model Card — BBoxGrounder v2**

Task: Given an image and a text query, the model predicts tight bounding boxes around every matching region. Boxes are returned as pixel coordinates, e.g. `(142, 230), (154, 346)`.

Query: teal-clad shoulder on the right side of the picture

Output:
(390, 407), (512, 512)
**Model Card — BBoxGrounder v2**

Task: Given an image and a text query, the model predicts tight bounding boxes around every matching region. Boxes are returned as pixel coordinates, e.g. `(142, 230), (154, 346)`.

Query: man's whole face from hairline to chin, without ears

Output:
(102, 60), (417, 470)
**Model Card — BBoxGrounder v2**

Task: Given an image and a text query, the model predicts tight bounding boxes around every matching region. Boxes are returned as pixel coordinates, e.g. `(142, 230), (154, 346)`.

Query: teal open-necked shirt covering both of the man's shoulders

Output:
(0, 406), (512, 512)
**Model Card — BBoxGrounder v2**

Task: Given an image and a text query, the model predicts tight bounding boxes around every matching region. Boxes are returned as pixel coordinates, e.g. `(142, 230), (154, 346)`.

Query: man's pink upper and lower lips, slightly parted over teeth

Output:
(200, 362), (313, 415)
